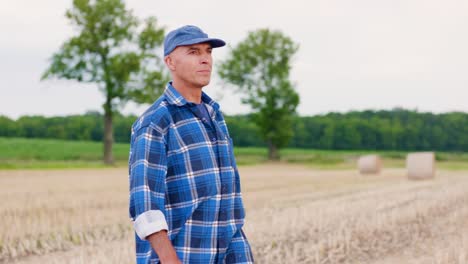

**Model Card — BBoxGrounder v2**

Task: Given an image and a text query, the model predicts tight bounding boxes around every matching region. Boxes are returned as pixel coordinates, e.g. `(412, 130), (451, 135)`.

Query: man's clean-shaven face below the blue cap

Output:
(166, 43), (212, 89)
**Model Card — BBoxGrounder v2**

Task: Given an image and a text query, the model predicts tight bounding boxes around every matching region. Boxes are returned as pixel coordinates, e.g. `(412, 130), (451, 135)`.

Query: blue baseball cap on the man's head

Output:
(164, 25), (226, 56)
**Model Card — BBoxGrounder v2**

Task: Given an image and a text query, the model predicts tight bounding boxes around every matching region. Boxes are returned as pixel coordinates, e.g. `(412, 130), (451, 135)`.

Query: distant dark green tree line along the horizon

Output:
(0, 109), (468, 151)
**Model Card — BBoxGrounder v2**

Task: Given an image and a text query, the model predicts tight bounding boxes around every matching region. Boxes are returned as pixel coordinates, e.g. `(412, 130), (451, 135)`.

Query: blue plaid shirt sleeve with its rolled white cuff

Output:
(129, 127), (168, 240)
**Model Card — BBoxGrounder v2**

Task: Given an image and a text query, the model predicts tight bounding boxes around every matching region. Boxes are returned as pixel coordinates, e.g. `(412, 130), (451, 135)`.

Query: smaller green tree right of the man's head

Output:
(218, 29), (299, 159)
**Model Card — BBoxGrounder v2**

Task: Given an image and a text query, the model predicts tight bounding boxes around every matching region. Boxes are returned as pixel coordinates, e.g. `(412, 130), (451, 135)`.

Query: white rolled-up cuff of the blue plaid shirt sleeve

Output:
(133, 210), (169, 240)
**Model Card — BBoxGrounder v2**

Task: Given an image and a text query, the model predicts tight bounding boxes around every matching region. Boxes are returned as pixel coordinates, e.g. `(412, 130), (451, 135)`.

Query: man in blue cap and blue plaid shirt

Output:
(129, 26), (253, 264)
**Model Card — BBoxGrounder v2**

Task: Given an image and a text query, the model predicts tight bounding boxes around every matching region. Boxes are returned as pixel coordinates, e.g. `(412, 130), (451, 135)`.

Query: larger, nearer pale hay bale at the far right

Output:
(406, 152), (435, 180)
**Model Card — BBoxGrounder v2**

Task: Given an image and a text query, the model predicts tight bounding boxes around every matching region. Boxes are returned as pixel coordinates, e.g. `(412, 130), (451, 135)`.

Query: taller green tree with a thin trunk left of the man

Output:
(42, 0), (168, 164)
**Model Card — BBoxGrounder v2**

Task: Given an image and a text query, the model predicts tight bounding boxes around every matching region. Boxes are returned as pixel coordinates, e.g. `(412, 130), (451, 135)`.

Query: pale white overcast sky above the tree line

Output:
(0, 0), (468, 118)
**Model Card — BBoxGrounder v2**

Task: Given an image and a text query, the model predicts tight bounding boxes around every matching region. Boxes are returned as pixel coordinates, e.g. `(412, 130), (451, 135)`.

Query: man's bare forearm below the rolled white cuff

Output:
(146, 230), (182, 264)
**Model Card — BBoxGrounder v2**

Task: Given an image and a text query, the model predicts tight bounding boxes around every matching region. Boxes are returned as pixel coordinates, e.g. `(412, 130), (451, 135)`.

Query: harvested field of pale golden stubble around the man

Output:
(0, 164), (468, 264)
